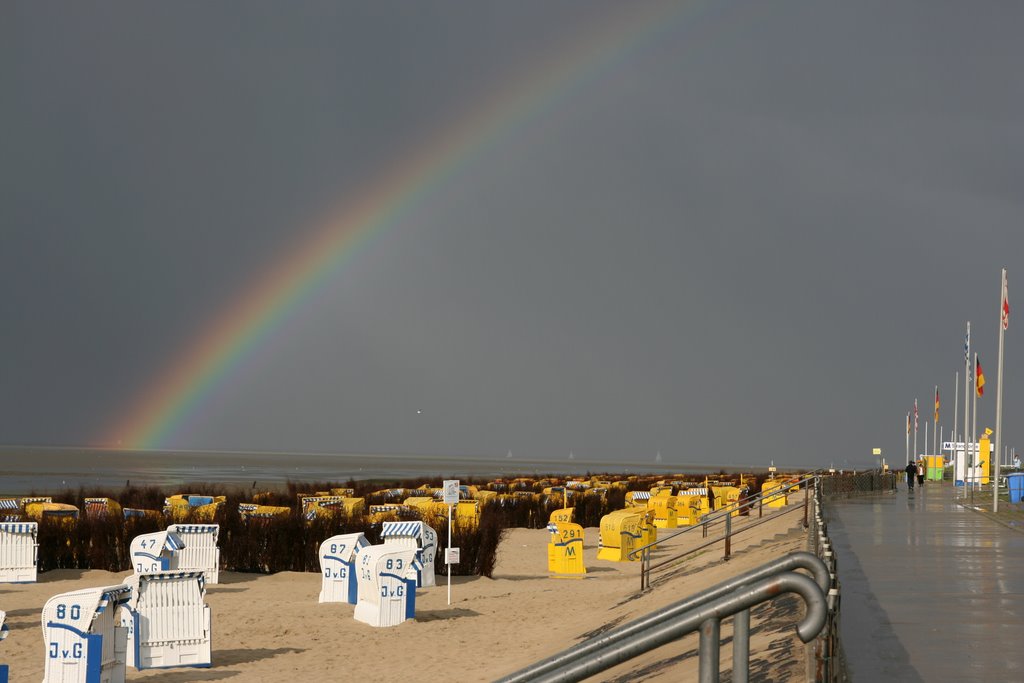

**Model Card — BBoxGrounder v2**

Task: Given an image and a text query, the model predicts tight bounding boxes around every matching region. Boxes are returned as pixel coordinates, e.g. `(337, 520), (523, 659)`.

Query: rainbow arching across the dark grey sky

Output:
(108, 2), (722, 450)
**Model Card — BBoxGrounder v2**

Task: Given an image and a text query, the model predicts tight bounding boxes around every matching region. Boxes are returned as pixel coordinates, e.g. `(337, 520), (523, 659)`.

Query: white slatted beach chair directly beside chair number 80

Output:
(121, 571), (211, 669)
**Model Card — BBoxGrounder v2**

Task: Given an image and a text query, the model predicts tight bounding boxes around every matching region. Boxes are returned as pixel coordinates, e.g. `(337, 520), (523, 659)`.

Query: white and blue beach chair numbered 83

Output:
(354, 545), (423, 627)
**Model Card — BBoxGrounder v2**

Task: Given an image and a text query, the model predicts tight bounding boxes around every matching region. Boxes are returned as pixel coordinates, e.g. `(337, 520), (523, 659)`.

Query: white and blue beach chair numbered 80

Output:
(42, 584), (131, 683)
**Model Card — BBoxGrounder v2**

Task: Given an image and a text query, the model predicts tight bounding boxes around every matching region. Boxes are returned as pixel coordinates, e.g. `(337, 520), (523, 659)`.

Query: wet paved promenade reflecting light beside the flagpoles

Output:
(825, 482), (1024, 683)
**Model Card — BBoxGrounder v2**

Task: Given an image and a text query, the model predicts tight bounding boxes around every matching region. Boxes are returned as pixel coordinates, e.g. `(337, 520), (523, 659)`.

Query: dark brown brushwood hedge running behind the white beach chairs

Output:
(28, 477), (760, 577)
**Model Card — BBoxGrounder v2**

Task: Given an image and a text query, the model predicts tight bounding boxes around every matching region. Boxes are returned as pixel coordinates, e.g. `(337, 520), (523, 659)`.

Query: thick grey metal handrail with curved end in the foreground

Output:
(491, 552), (828, 683)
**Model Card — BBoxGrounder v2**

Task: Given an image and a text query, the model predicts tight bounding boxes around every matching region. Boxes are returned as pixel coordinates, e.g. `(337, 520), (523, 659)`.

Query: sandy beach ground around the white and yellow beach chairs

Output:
(0, 503), (806, 683)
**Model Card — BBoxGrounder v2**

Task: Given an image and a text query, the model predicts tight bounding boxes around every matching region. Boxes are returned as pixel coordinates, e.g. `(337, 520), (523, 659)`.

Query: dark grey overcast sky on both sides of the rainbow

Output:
(0, 0), (1024, 466)
